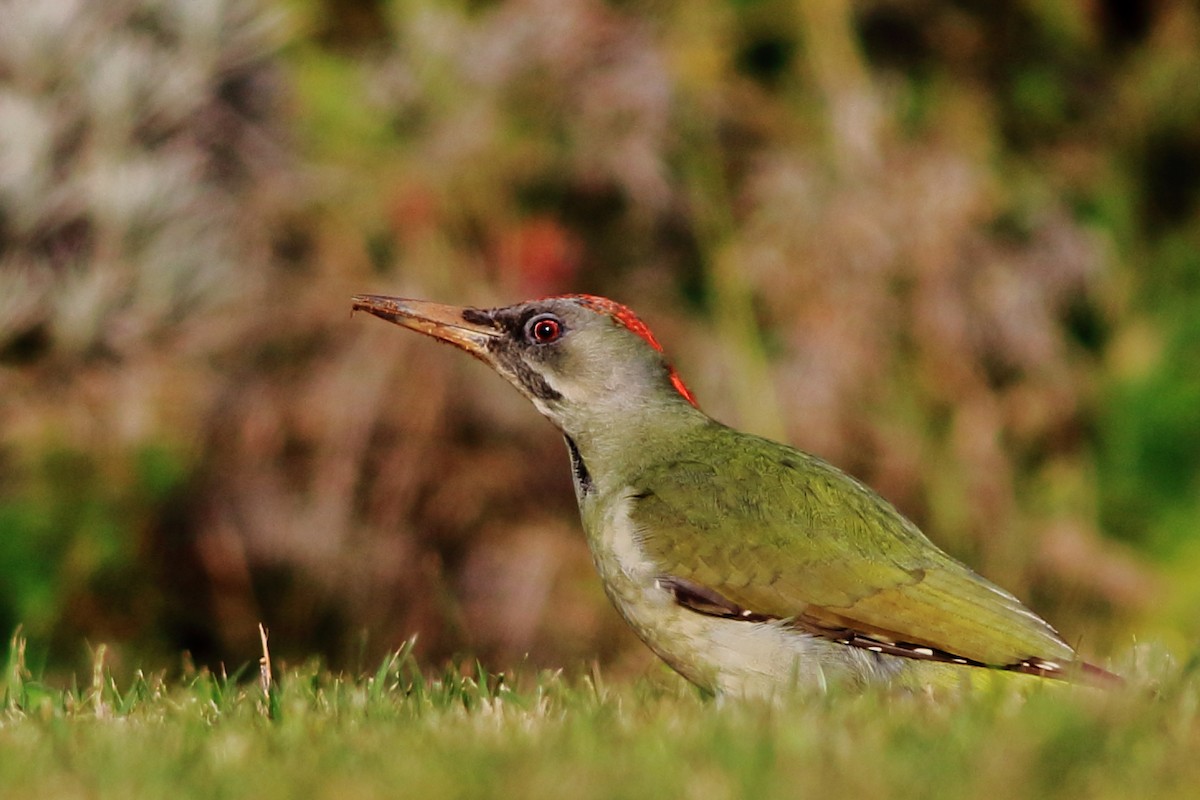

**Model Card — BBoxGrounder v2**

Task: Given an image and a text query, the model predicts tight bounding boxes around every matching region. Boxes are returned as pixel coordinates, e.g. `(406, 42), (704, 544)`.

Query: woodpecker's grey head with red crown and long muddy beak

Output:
(354, 295), (696, 434)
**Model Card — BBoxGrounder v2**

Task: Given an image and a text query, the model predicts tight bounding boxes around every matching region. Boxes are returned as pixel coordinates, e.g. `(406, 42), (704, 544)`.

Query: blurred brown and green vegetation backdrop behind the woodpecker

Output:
(0, 0), (1200, 675)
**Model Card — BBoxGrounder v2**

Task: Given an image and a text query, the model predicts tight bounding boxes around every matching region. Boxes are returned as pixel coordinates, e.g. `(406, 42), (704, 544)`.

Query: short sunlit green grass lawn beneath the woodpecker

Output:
(0, 638), (1200, 800)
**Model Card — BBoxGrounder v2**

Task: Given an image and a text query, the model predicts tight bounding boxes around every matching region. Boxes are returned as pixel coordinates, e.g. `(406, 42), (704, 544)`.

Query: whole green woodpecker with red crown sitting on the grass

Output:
(353, 294), (1121, 697)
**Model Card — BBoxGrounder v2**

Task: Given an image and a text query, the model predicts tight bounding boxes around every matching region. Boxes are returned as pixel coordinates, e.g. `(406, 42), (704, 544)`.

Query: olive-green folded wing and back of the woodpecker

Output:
(631, 426), (1075, 667)
